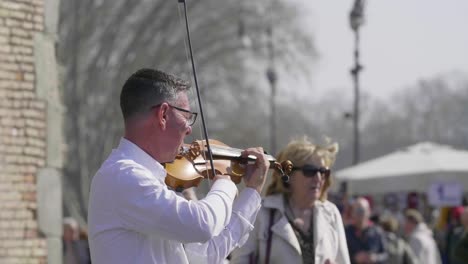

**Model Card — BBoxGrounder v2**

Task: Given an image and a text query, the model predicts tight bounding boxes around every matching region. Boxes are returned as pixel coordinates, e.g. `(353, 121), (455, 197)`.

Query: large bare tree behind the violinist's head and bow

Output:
(58, 0), (315, 225)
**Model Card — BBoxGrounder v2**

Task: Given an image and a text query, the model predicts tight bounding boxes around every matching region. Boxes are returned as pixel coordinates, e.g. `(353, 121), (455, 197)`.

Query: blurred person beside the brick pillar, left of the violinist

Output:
(62, 217), (91, 264)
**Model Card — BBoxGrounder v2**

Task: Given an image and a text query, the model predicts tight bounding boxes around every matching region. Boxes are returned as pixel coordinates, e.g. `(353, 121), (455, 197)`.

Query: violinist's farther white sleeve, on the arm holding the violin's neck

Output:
(185, 188), (261, 263)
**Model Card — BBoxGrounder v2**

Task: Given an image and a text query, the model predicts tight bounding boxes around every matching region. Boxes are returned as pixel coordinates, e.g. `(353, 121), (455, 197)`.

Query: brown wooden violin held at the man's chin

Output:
(165, 139), (293, 192)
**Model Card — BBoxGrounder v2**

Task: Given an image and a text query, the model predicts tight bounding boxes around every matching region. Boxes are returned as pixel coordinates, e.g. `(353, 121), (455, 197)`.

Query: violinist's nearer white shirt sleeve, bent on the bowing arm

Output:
(115, 168), (237, 243)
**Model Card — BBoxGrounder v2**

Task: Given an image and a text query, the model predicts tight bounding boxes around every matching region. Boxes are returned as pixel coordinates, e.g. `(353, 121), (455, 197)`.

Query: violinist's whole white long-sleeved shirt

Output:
(88, 138), (261, 264)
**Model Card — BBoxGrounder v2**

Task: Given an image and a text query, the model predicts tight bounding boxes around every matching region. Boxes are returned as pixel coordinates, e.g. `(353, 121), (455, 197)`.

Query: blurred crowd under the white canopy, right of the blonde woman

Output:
(336, 197), (468, 264)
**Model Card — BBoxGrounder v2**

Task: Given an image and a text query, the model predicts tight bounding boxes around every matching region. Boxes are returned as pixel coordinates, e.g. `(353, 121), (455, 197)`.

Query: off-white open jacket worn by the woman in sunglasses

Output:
(231, 194), (350, 264)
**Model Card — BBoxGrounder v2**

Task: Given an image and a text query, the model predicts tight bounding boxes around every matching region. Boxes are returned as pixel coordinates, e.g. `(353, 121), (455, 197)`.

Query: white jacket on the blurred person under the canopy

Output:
(409, 223), (442, 264)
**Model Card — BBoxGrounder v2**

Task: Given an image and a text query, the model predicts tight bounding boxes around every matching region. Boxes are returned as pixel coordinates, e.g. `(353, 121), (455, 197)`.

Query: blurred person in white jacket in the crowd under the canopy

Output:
(404, 209), (442, 264)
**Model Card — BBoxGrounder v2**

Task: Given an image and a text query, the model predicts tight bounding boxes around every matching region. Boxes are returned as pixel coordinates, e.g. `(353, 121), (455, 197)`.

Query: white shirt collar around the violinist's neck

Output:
(117, 138), (166, 178)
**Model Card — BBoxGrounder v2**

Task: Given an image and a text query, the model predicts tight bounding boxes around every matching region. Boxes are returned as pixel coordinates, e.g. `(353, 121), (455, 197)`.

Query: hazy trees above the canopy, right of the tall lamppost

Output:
(352, 74), (468, 167)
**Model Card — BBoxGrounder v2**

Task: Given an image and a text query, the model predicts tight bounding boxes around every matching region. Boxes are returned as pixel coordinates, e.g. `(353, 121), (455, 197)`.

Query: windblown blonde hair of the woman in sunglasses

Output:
(266, 137), (338, 201)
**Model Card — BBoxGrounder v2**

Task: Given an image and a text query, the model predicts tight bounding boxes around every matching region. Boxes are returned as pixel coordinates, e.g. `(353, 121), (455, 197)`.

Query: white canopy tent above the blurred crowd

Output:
(335, 142), (468, 194)
